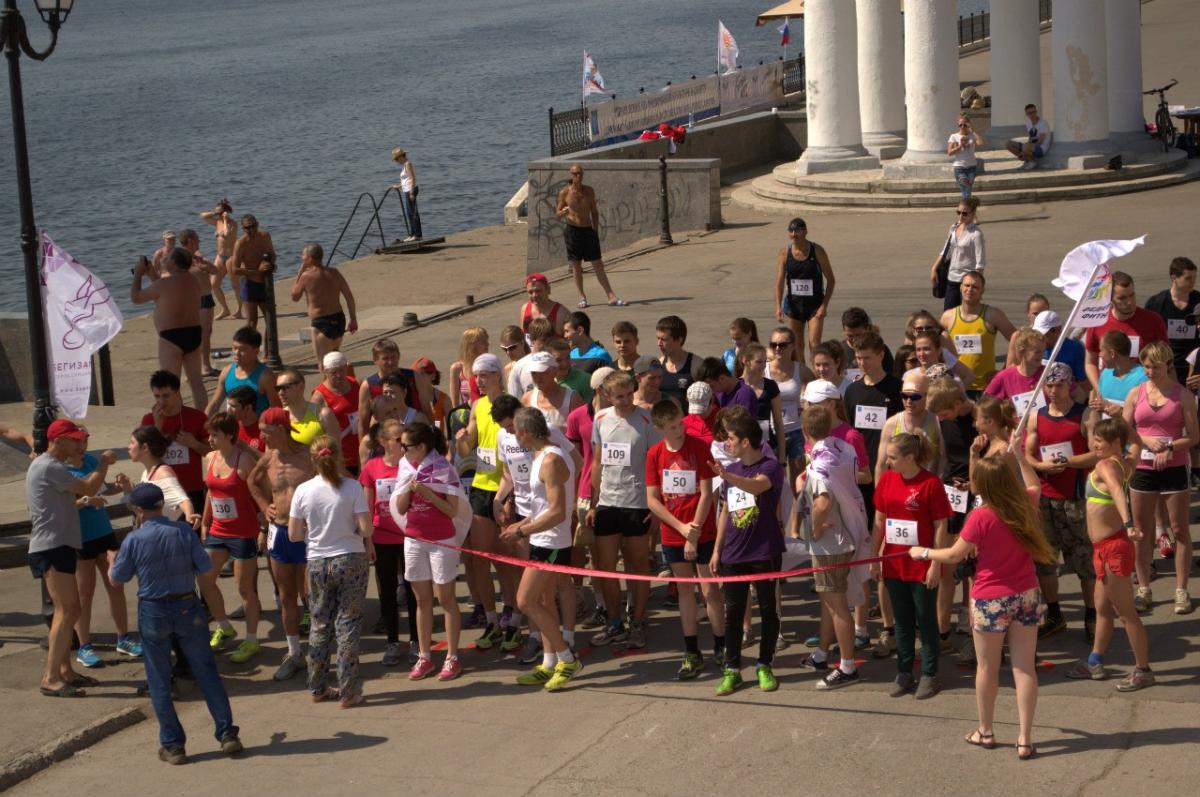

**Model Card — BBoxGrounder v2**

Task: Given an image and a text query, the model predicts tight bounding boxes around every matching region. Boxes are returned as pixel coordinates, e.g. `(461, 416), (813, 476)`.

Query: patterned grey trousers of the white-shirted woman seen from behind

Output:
(308, 553), (370, 700)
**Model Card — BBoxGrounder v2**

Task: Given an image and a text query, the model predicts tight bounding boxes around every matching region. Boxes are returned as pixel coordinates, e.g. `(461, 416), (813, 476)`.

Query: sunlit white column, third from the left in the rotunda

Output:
(883, 0), (959, 176)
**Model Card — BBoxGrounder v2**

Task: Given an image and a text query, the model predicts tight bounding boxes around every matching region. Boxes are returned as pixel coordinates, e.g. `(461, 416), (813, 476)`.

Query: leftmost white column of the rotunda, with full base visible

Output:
(796, 0), (880, 174)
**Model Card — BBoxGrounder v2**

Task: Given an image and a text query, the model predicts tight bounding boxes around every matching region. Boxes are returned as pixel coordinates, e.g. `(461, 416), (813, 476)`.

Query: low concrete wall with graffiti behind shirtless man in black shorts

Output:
(526, 157), (721, 274)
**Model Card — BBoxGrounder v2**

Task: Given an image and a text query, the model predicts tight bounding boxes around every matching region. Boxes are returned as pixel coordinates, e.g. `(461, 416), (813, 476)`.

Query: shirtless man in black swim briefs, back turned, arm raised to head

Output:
(130, 246), (209, 407)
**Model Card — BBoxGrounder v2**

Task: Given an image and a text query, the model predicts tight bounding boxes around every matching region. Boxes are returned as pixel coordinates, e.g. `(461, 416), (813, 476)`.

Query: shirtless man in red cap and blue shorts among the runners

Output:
(247, 407), (316, 681)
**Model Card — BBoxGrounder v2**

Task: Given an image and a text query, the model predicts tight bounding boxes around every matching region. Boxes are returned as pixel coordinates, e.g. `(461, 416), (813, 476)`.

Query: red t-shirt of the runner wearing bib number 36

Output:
(875, 469), (954, 581)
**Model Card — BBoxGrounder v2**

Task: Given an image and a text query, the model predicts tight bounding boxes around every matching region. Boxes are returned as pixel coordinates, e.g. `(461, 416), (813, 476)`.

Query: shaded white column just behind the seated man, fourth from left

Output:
(988, 0), (1041, 141)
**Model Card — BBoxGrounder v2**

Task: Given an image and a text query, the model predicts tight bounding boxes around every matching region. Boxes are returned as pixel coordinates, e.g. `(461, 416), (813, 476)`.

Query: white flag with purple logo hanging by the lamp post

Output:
(42, 230), (122, 418)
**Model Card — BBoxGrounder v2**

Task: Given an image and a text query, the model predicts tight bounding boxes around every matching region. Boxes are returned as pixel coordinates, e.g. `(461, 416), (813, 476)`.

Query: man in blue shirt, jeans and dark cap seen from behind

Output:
(109, 483), (242, 763)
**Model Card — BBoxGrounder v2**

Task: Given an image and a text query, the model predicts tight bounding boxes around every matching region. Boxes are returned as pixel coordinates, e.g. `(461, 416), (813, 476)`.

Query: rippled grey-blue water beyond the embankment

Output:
(0, 0), (986, 311)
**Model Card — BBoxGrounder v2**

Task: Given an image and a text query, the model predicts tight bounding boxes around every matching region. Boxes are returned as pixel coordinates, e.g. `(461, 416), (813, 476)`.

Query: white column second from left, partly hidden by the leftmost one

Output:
(857, 0), (902, 158)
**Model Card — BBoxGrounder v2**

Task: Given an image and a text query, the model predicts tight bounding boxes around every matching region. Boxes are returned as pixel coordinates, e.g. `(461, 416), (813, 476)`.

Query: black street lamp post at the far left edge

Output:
(0, 0), (73, 453)
